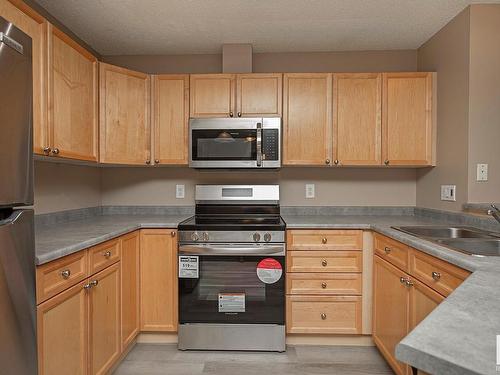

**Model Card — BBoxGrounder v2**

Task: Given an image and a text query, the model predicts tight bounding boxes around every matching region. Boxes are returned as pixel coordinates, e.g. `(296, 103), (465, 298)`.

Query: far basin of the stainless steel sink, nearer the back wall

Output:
(395, 226), (498, 239)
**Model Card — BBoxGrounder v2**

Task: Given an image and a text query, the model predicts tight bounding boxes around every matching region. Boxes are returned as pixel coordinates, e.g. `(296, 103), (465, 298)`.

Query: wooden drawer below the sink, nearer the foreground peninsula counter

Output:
(410, 249), (470, 297)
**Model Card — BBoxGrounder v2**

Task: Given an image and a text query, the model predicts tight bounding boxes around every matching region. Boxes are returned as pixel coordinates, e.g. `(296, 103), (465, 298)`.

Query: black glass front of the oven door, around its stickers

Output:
(179, 256), (285, 324)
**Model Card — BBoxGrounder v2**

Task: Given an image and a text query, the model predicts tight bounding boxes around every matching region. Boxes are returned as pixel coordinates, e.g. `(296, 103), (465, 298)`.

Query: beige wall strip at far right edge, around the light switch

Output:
(468, 4), (500, 203)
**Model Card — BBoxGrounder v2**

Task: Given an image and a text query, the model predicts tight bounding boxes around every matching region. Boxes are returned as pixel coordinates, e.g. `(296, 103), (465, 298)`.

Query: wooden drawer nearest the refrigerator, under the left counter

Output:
(36, 250), (87, 304)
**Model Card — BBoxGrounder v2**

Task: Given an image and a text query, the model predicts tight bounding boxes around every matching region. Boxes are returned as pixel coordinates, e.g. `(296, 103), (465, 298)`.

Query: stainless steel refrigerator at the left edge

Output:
(0, 17), (37, 375)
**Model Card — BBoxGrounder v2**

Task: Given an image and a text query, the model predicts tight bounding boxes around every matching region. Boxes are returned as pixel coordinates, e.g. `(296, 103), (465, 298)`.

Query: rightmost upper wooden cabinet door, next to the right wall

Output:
(382, 73), (435, 166)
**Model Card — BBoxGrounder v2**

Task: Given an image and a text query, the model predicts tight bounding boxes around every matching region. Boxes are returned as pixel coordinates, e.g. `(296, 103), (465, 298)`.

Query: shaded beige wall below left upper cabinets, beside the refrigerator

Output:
(34, 161), (101, 214)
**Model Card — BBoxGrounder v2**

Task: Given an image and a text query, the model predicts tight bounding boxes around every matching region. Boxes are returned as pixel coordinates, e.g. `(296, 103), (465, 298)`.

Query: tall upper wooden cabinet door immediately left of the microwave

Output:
(153, 74), (189, 164)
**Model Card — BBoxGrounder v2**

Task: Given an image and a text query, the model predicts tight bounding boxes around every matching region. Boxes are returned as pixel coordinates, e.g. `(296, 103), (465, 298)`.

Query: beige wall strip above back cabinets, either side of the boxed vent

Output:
(103, 50), (417, 73)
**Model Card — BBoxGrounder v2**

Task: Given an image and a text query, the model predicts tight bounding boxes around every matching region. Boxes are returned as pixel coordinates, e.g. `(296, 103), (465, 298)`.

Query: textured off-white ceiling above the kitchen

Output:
(37, 0), (500, 55)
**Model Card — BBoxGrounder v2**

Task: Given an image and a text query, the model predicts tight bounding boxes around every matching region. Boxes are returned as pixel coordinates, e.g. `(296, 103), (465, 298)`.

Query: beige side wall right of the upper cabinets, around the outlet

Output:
(417, 8), (470, 211)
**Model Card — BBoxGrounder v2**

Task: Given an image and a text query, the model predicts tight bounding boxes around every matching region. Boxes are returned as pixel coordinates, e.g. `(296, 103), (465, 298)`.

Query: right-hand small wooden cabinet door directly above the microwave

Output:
(236, 73), (283, 117)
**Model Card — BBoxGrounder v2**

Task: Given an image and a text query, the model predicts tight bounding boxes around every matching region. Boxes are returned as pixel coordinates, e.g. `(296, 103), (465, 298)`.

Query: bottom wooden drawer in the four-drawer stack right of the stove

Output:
(286, 296), (361, 334)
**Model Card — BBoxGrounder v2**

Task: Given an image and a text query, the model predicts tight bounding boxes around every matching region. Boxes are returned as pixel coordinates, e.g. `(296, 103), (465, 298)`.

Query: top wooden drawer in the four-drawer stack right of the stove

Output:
(287, 229), (363, 250)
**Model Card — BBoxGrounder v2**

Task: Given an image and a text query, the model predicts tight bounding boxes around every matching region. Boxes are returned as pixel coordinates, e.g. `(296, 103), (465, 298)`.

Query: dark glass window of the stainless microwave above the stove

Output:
(191, 129), (257, 160)
